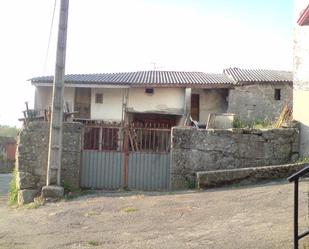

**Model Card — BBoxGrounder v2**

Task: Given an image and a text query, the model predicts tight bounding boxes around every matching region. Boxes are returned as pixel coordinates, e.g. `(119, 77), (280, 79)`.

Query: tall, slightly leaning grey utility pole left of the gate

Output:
(46, 0), (69, 186)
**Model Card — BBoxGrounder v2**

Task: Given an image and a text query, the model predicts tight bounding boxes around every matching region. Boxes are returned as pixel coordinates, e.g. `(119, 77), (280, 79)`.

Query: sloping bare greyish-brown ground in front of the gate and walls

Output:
(0, 177), (309, 249)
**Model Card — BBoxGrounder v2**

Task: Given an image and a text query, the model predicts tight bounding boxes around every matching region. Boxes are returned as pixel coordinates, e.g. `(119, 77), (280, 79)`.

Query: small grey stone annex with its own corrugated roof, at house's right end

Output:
(224, 68), (293, 122)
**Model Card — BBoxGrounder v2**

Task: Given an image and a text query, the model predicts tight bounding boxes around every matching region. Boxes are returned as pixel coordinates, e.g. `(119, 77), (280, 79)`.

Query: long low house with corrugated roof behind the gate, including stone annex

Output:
(31, 68), (292, 127)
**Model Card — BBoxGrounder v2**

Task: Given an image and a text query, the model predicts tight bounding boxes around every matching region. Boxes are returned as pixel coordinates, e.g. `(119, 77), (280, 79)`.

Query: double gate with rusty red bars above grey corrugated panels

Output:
(80, 124), (171, 191)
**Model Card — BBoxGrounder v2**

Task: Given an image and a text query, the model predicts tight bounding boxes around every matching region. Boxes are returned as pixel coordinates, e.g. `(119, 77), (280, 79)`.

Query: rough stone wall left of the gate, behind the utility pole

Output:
(16, 122), (82, 202)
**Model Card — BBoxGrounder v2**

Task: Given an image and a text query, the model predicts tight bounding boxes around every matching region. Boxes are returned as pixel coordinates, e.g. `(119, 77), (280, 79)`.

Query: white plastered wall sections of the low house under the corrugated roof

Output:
(35, 86), (185, 121)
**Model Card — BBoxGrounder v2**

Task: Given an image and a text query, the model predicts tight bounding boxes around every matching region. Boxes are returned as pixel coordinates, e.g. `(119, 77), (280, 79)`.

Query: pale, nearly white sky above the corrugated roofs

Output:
(0, 0), (293, 126)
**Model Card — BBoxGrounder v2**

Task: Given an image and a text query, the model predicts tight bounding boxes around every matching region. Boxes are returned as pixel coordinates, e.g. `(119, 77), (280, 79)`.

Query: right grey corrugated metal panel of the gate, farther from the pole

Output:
(128, 152), (170, 191)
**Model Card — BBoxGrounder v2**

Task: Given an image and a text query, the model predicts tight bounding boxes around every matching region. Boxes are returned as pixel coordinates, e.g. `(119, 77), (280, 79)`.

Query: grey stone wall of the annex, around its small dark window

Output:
(227, 84), (293, 121)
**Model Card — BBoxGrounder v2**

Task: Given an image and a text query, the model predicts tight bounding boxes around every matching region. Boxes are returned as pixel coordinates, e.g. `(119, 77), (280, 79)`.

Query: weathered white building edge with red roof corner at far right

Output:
(293, 0), (309, 156)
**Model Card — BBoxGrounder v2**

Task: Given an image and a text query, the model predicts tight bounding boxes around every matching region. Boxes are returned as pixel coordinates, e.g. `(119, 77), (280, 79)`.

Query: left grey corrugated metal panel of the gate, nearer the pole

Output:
(81, 150), (124, 189)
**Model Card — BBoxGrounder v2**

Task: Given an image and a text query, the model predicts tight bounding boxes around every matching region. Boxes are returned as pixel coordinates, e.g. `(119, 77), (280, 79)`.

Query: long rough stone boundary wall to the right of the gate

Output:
(171, 128), (299, 189)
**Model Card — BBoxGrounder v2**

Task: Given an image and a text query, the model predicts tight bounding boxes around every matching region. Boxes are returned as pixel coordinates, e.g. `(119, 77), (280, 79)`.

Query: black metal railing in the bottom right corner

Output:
(288, 165), (309, 249)
